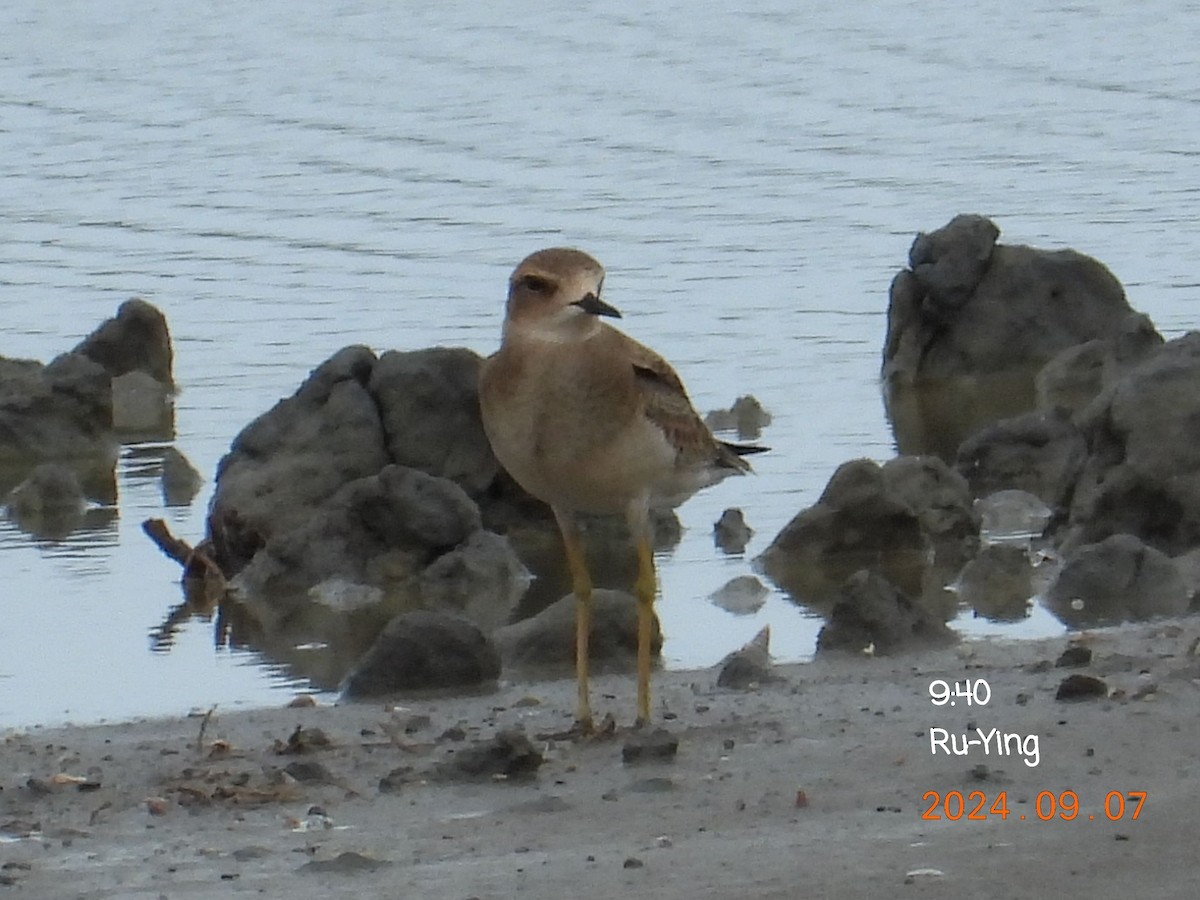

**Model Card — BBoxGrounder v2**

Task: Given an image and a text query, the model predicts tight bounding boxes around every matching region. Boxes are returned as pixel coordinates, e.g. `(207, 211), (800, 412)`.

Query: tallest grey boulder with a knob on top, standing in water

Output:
(883, 216), (1152, 458)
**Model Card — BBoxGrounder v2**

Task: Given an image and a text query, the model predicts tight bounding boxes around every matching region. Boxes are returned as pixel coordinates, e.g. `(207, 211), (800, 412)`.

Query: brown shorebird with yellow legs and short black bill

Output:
(479, 247), (767, 732)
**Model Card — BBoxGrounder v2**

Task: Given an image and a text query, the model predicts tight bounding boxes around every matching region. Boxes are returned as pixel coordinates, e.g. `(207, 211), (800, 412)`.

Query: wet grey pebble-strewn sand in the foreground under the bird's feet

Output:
(0, 618), (1200, 900)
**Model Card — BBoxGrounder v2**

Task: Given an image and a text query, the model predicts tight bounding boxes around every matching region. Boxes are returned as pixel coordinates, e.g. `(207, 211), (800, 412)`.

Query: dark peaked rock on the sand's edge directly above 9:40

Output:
(817, 570), (954, 655)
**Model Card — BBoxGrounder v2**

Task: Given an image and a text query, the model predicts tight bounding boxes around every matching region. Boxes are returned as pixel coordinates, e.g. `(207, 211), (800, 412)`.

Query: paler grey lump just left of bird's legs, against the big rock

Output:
(420, 530), (532, 632)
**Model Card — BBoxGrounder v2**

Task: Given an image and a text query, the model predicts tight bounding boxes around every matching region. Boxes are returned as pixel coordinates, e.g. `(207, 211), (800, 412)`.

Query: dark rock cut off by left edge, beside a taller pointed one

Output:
(0, 354), (118, 472)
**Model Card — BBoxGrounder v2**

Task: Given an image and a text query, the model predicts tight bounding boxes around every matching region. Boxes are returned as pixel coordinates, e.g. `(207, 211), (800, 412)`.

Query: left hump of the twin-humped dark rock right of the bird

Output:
(755, 460), (931, 602)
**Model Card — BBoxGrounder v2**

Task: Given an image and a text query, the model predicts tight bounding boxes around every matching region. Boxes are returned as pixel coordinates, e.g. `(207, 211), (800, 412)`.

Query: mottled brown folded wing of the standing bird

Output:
(622, 335), (750, 472)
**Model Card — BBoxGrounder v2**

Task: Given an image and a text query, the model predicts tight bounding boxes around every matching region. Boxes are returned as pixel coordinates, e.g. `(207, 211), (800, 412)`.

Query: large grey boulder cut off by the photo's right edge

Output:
(1069, 332), (1200, 556)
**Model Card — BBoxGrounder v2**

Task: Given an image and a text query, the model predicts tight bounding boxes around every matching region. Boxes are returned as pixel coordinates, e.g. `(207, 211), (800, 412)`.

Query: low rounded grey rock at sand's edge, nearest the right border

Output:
(1044, 534), (1190, 628)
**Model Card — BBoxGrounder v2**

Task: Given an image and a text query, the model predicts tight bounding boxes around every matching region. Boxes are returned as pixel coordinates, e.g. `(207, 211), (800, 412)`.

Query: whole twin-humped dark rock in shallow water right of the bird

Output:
(756, 457), (979, 602)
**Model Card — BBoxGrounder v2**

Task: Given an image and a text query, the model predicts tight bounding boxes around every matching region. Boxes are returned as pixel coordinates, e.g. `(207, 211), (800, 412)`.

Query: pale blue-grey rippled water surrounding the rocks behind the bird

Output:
(0, 0), (1200, 725)
